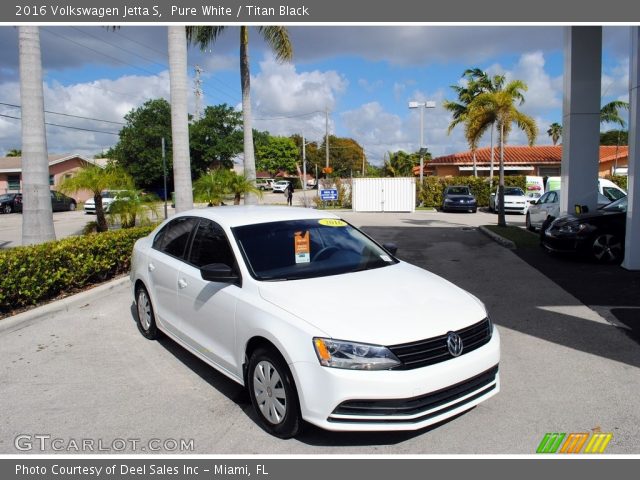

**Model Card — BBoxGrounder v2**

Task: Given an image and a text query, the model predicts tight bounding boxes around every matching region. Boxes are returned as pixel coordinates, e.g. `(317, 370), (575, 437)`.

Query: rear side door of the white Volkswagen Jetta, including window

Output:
(146, 217), (198, 336)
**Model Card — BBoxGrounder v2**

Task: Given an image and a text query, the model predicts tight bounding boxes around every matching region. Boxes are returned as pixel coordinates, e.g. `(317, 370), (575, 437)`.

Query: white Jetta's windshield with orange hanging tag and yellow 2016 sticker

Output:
(233, 218), (397, 280)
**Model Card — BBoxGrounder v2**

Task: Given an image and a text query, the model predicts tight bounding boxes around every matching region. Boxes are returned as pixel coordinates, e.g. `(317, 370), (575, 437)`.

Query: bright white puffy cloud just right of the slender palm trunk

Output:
(251, 57), (348, 140)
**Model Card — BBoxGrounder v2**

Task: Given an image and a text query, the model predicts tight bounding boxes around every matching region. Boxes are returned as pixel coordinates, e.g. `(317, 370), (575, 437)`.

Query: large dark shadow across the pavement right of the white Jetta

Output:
(363, 227), (640, 367)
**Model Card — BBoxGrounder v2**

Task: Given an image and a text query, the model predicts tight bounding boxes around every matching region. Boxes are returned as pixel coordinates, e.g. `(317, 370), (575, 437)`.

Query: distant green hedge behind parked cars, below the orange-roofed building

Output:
(418, 175), (526, 207)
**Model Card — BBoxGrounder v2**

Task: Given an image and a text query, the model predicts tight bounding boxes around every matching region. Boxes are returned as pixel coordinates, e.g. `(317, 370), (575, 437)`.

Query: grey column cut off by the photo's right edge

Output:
(622, 27), (640, 270)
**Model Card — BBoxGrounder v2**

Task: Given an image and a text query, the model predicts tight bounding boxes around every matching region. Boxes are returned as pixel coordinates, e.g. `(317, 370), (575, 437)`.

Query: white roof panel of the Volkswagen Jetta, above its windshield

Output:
(172, 205), (339, 228)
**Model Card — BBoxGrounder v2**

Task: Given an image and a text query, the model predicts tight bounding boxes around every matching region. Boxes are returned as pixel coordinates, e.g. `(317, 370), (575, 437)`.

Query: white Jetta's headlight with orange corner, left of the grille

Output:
(313, 337), (401, 370)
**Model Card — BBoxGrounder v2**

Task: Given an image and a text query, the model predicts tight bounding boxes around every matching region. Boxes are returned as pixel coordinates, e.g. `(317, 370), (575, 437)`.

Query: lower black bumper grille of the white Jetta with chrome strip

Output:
(328, 365), (498, 423)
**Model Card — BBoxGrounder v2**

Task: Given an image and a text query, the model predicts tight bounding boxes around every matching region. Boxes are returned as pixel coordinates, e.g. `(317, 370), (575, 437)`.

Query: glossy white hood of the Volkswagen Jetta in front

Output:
(259, 262), (486, 345)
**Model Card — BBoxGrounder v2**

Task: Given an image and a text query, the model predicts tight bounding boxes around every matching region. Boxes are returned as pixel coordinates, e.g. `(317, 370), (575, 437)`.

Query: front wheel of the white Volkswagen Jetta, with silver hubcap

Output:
(247, 348), (302, 438)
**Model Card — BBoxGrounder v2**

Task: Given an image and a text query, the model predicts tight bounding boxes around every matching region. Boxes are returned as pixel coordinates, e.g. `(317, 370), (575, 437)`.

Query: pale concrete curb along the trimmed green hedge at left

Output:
(0, 275), (130, 332)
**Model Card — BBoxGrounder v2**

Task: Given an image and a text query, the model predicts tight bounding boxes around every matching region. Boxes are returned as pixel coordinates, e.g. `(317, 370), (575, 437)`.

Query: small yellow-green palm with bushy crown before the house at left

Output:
(59, 165), (133, 232)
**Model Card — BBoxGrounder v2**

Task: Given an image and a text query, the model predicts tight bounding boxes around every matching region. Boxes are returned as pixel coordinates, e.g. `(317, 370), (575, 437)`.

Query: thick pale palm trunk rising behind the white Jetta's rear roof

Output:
(167, 25), (193, 213)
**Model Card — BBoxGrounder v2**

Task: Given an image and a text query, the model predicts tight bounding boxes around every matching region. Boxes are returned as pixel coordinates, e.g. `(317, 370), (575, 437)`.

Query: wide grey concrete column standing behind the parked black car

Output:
(560, 26), (602, 214)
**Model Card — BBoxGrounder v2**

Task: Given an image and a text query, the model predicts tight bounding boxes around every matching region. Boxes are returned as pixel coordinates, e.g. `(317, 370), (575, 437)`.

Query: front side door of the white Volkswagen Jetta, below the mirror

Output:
(178, 219), (242, 376)
